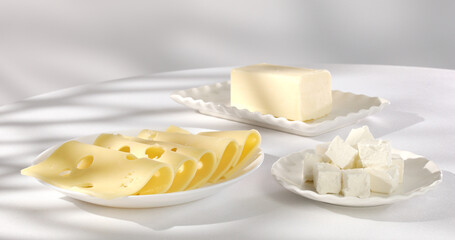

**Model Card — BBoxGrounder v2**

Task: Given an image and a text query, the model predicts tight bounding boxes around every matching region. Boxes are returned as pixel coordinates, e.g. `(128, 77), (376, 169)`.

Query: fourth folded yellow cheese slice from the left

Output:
(138, 129), (240, 182)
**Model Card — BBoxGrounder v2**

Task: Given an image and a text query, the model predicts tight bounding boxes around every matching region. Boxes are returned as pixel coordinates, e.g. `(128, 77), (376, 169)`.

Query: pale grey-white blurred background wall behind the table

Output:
(0, 0), (455, 105)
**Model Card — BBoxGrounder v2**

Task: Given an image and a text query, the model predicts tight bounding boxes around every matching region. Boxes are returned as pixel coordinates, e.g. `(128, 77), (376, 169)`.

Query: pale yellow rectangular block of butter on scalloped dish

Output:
(231, 64), (332, 121)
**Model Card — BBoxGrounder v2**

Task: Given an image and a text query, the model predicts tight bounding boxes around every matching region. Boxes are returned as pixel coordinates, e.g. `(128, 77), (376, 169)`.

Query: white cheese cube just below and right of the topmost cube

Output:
(357, 140), (392, 167)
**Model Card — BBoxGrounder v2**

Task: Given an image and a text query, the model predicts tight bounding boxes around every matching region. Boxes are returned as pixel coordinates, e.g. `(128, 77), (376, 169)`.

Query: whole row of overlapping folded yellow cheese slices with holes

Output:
(22, 126), (261, 199)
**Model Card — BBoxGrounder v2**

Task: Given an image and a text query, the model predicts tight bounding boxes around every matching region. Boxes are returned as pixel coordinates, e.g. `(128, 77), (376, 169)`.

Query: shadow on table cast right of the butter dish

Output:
(313, 109), (425, 142)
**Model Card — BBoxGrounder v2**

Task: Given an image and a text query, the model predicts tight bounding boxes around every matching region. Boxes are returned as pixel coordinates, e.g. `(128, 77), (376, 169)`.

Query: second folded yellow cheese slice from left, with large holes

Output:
(94, 134), (197, 192)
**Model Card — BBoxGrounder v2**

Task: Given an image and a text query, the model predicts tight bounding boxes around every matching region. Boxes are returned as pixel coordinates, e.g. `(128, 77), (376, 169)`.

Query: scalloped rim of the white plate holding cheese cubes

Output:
(271, 149), (443, 207)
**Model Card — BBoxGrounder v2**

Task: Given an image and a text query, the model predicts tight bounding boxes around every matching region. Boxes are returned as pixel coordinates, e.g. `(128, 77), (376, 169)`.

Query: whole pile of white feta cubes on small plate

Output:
(302, 126), (404, 198)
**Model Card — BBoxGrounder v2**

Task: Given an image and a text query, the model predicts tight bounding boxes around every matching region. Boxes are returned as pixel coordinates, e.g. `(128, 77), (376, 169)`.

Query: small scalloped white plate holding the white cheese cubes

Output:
(272, 149), (442, 207)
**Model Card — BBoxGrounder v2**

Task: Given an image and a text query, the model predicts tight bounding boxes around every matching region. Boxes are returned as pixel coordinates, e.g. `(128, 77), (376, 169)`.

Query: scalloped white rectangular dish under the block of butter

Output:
(170, 81), (390, 136)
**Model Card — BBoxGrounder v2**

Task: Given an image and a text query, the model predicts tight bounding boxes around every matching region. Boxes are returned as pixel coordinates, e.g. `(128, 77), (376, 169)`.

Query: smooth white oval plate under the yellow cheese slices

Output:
(33, 128), (264, 208)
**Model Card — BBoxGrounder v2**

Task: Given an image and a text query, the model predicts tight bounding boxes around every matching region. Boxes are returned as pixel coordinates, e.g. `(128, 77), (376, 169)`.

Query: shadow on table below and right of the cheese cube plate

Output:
(308, 171), (455, 222)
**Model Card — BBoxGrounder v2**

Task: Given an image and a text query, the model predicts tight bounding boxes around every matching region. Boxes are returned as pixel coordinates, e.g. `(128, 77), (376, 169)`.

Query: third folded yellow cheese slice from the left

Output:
(122, 136), (218, 190)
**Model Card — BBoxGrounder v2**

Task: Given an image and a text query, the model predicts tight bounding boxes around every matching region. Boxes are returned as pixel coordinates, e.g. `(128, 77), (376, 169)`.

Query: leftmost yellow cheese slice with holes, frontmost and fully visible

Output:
(21, 141), (174, 199)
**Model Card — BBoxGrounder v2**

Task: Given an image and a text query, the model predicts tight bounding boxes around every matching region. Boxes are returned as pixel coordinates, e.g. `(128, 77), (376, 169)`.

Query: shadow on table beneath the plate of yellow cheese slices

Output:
(63, 154), (278, 230)
